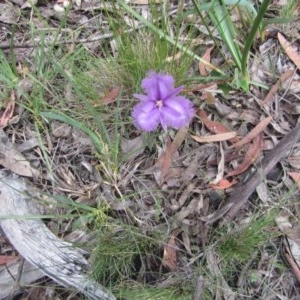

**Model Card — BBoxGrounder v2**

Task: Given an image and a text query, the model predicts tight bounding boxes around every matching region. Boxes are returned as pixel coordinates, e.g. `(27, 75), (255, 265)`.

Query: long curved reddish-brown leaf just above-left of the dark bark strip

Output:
(225, 134), (263, 178)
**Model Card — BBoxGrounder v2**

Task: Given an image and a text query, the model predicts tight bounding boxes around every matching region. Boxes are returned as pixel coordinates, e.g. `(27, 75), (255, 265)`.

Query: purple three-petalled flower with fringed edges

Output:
(132, 71), (195, 131)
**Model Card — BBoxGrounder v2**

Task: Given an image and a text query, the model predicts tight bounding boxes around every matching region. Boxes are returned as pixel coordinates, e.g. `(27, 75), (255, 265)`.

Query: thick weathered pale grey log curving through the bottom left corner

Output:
(0, 171), (116, 300)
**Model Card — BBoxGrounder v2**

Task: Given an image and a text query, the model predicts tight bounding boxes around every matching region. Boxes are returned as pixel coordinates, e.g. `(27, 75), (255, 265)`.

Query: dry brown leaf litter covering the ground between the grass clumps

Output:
(0, 0), (300, 299)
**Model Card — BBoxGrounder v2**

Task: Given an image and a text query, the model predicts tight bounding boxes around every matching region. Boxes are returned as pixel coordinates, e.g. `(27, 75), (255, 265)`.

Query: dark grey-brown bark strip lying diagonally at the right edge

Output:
(201, 123), (300, 224)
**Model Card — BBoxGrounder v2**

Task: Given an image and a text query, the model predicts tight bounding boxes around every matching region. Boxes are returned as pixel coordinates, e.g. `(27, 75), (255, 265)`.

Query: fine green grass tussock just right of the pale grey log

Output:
(91, 222), (159, 286)
